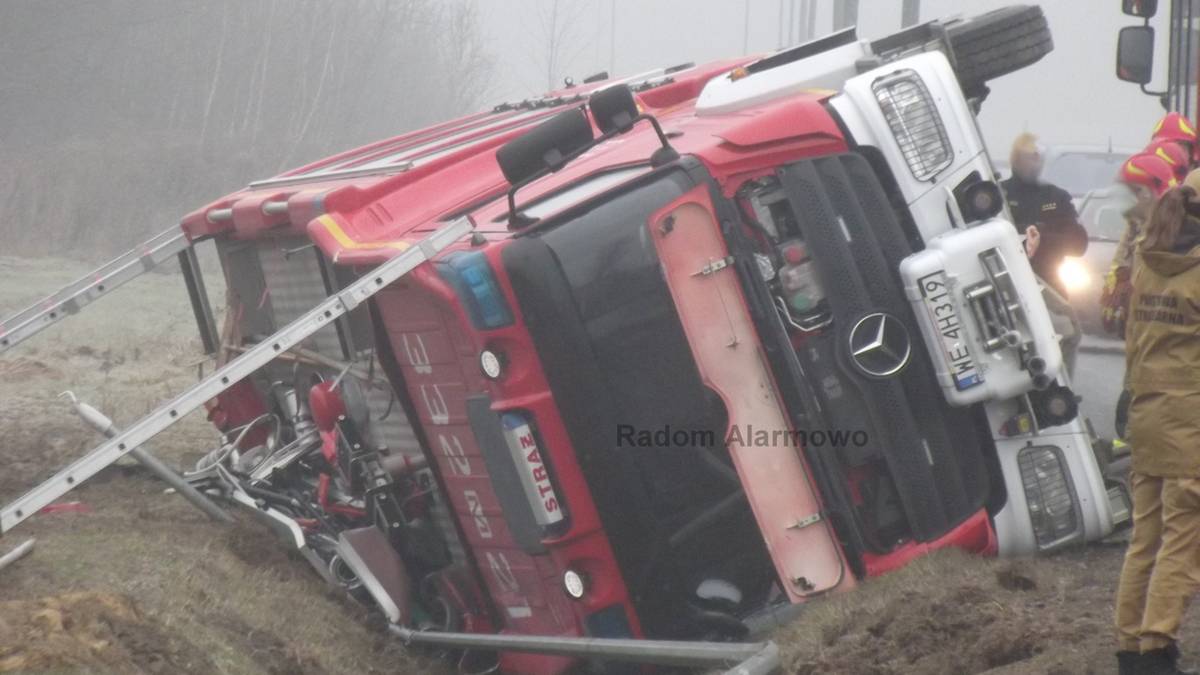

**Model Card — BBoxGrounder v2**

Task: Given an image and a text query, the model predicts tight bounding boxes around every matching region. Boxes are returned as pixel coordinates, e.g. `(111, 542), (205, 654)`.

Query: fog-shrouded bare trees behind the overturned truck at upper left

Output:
(0, 0), (491, 257)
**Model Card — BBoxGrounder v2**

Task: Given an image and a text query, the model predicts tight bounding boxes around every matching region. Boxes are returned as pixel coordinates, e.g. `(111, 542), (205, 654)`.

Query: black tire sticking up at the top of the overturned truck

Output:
(946, 5), (1054, 95)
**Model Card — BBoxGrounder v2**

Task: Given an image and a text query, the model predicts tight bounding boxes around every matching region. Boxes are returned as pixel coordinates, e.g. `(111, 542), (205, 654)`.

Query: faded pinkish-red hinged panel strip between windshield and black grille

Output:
(649, 186), (854, 602)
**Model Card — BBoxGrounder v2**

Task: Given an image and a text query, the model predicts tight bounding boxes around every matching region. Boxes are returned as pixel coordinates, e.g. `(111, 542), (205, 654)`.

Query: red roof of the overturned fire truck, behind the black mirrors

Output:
(182, 58), (845, 264)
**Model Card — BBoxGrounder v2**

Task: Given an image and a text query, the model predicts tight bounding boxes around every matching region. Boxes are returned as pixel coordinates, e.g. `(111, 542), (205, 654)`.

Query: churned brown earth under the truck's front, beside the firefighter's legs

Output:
(776, 544), (1200, 675)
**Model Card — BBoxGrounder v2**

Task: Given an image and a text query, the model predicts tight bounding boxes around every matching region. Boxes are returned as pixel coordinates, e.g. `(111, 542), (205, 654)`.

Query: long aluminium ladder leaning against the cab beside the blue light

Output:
(0, 217), (473, 534)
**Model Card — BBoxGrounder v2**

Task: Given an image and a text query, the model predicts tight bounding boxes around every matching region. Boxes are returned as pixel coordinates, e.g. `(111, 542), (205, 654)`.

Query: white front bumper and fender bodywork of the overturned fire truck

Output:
(697, 41), (1114, 547)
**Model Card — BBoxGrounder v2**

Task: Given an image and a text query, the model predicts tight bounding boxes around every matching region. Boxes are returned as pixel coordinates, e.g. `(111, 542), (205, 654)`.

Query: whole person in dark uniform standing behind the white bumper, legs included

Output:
(1000, 133), (1087, 374)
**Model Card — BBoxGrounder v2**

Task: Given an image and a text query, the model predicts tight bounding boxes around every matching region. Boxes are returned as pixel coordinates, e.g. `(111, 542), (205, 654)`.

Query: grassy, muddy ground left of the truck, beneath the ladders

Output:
(0, 257), (436, 674)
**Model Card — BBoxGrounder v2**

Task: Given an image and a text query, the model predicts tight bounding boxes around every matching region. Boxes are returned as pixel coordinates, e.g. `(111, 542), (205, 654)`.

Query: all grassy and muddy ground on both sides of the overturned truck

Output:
(0, 257), (1185, 675)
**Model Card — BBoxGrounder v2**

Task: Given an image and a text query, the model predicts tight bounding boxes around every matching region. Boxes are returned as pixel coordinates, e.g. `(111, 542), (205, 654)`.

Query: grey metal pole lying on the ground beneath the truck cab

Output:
(388, 623), (781, 675)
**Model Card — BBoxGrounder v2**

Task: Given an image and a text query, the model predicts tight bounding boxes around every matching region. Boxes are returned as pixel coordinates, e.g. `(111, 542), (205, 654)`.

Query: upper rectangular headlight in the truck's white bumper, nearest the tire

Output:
(871, 68), (954, 180)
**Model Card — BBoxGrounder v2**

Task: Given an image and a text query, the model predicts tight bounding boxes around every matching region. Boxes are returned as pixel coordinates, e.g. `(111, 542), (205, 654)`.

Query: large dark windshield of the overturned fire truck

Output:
(504, 165), (774, 631)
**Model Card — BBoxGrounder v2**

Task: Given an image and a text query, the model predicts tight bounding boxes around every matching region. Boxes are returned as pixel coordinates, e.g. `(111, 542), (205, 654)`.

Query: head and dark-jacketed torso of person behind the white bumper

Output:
(1000, 133), (1087, 295)
